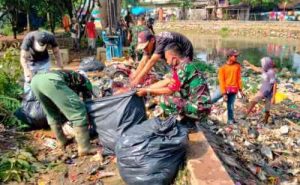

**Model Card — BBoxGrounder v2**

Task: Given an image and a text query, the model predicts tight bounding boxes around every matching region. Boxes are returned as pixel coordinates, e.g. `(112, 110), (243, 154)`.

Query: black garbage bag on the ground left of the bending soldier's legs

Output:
(14, 90), (48, 128)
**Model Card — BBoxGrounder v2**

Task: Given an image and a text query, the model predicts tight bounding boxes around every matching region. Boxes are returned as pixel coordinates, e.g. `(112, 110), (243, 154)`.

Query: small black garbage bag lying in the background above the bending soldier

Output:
(79, 57), (105, 72)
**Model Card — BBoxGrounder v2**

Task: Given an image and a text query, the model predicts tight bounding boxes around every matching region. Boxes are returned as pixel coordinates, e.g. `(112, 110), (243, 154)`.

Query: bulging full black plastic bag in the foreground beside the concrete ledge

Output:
(116, 117), (188, 185)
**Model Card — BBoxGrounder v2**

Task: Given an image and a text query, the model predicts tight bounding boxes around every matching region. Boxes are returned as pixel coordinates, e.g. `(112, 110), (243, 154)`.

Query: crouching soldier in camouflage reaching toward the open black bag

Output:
(138, 43), (211, 121)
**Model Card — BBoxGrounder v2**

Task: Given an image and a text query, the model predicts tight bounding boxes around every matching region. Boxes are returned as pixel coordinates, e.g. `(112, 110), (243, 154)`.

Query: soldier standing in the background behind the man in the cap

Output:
(128, 16), (149, 61)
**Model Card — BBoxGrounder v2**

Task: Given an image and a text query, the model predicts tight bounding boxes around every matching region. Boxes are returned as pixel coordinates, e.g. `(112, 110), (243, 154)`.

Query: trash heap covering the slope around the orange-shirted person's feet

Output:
(202, 69), (300, 184)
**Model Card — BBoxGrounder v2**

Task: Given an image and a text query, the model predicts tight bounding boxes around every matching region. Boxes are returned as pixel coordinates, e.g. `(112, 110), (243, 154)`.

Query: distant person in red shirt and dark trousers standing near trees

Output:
(85, 17), (97, 54)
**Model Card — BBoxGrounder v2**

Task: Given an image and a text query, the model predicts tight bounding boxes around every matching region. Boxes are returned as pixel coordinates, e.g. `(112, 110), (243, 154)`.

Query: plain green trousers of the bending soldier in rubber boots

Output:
(31, 73), (87, 126)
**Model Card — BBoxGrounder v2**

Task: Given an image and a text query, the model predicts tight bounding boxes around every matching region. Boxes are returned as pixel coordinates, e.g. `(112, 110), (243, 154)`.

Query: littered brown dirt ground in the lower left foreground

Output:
(0, 125), (124, 185)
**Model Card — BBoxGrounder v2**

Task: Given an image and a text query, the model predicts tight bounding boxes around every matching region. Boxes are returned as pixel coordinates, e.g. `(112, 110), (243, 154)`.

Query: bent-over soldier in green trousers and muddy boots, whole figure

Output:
(31, 70), (97, 156)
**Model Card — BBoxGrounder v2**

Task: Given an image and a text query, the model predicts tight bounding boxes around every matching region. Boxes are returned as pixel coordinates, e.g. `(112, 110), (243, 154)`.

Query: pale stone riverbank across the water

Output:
(155, 20), (300, 39)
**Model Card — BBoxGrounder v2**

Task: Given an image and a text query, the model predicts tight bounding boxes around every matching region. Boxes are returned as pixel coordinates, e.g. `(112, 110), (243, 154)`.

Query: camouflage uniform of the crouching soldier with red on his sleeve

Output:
(160, 61), (211, 121)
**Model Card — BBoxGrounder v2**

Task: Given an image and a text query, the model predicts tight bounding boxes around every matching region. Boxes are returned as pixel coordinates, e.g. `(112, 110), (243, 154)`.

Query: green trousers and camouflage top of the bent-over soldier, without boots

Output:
(31, 71), (92, 126)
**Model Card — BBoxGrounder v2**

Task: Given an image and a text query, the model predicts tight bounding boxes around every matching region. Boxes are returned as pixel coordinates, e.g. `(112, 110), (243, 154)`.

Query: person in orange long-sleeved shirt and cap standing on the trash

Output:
(212, 50), (244, 124)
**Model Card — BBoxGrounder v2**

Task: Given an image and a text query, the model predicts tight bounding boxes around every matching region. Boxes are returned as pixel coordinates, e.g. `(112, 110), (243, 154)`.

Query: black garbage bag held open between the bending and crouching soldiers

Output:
(86, 91), (146, 155)
